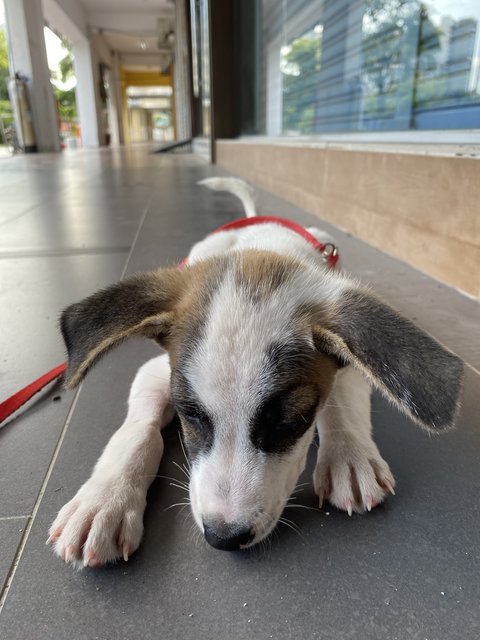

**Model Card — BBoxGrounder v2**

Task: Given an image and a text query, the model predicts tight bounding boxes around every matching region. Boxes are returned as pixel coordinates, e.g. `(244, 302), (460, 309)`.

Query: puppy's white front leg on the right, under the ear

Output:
(314, 367), (395, 515)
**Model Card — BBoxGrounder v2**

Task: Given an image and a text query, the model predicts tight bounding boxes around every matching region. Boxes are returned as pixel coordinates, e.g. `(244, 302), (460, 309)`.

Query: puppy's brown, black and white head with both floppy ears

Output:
(62, 251), (463, 549)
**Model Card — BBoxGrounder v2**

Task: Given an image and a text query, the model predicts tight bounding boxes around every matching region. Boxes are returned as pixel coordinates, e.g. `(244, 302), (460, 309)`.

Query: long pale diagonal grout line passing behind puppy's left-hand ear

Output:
(0, 191), (153, 615)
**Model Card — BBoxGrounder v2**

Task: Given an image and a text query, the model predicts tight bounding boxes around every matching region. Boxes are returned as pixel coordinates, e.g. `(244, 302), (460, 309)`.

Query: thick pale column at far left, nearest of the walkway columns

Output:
(4, 0), (60, 151)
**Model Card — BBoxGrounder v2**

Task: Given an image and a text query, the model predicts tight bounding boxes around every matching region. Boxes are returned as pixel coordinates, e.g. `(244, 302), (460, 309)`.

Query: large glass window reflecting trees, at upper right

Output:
(262, 0), (480, 135)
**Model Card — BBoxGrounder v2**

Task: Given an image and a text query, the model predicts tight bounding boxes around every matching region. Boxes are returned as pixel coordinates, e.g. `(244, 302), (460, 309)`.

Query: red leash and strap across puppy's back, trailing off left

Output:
(0, 216), (338, 424)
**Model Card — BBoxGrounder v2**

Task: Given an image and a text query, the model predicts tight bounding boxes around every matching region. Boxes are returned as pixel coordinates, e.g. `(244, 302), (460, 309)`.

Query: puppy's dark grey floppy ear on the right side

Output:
(313, 288), (463, 431)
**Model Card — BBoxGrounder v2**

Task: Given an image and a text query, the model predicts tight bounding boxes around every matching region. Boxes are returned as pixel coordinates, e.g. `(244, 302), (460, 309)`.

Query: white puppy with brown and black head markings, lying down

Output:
(49, 178), (463, 567)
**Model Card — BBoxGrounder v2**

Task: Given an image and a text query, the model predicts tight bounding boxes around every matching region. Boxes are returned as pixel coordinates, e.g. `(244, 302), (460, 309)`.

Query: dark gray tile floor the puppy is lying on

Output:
(0, 148), (480, 640)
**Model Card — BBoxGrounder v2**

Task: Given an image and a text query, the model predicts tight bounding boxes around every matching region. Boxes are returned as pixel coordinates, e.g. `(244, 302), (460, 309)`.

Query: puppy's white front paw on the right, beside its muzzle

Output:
(313, 436), (395, 515)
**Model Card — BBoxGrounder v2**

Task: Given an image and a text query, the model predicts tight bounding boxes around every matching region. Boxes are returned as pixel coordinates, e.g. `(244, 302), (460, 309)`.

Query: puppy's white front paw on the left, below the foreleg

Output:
(47, 477), (146, 568)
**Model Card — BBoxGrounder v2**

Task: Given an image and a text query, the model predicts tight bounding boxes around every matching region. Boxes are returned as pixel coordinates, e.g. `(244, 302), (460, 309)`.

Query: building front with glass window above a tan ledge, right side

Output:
(194, 0), (480, 296)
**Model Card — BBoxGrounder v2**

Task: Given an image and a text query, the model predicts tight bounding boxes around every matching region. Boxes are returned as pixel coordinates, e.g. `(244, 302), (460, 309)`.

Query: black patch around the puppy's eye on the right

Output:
(250, 386), (319, 454)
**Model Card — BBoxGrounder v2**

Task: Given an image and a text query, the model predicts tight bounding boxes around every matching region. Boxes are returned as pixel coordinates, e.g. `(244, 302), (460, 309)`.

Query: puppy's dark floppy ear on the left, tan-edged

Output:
(60, 269), (181, 388)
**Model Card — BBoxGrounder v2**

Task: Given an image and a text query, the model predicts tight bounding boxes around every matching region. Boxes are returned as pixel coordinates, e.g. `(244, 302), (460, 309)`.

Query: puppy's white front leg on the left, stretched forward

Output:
(48, 354), (174, 567)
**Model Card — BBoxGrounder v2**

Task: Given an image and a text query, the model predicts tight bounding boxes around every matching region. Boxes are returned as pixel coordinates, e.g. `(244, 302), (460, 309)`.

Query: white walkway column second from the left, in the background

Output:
(72, 37), (101, 147)
